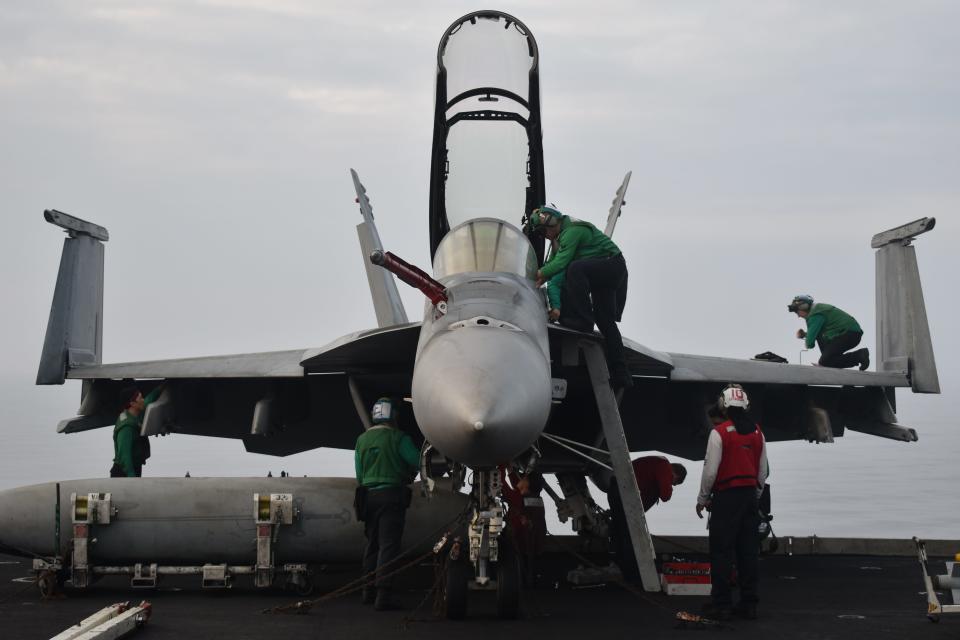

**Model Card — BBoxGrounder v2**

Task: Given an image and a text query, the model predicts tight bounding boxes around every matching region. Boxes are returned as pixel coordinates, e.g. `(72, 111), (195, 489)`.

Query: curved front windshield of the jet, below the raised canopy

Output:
(433, 218), (537, 280)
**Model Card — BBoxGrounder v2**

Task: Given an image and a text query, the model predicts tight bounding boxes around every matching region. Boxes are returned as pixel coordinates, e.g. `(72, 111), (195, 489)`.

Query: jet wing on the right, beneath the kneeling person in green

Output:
(544, 329), (917, 465)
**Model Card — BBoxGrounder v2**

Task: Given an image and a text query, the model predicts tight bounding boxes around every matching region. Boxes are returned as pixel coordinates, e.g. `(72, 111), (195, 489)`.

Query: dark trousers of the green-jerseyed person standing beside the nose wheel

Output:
(363, 487), (407, 589)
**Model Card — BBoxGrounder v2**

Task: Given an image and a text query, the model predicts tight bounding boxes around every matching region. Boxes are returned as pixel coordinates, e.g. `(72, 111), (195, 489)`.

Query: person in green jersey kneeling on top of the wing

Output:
(787, 295), (870, 371)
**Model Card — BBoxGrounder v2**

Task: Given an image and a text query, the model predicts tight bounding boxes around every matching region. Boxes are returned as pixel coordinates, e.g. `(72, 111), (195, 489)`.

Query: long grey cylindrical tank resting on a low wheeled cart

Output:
(0, 477), (467, 572)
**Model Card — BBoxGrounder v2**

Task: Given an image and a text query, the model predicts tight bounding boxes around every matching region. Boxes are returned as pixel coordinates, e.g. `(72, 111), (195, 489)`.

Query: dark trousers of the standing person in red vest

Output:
(710, 487), (760, 609)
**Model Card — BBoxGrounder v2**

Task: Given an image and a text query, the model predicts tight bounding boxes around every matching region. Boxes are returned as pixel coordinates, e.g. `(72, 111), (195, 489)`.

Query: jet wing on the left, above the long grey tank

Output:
(58, 323), (420, 455)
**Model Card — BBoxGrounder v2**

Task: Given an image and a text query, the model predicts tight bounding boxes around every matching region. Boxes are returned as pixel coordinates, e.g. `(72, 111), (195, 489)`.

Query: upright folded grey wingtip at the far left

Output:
(37, 209), (110, 384)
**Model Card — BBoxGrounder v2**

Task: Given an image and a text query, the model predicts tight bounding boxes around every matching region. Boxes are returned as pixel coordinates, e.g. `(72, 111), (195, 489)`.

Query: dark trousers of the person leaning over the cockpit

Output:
(560, 254), (632, 386)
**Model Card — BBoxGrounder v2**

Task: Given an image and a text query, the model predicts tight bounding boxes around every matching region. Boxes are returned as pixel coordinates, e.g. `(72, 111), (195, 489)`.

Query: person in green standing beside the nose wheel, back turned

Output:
(354, 398), (420, 611)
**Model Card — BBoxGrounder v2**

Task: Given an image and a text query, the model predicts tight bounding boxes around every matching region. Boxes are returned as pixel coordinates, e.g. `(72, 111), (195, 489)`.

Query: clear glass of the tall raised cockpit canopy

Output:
(441, 15), (536, 229)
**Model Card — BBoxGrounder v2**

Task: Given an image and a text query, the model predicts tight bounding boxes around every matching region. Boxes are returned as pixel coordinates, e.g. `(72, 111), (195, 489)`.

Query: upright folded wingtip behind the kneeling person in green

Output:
(870, 218), (940, 393)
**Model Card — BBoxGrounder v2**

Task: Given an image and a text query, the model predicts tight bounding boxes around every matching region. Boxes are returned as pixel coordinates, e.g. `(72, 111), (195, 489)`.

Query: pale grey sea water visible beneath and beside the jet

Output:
(0, 376), (960, 540)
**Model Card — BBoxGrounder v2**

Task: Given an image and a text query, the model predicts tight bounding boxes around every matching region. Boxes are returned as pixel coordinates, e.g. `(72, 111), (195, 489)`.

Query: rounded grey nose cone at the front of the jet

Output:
(413, 327), (551, 467)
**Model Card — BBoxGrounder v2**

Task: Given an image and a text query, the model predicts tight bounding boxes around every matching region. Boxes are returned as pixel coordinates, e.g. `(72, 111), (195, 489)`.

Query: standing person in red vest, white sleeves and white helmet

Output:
(697, 384), (768, 620)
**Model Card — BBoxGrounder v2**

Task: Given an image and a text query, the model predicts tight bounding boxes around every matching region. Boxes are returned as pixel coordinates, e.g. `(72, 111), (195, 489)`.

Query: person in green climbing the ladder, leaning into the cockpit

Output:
(527, 206), (633, 389)
